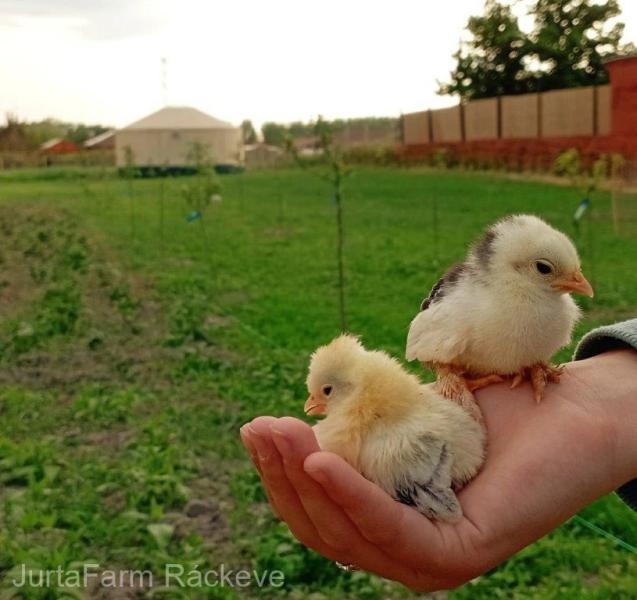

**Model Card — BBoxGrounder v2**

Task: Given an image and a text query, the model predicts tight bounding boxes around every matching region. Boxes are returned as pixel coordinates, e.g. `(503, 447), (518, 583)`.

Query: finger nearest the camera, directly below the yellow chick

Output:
(304, 452), (452, 576)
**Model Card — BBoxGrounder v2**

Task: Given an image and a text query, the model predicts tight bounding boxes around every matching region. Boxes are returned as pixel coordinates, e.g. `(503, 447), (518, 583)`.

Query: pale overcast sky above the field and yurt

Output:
(0, 0), (637, 127)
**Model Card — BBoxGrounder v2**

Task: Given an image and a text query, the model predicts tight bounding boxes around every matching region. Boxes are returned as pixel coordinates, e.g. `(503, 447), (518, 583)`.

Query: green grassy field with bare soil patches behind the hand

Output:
(0, 169), (637, 600)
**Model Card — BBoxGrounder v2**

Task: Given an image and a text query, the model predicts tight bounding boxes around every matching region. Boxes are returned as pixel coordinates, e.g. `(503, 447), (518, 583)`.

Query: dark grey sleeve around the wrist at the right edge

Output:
(573, 319), (637, 510)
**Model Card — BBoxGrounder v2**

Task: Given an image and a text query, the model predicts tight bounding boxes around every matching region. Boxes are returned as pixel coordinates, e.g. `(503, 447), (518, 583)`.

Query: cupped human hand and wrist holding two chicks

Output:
(241, 351), (637, 591)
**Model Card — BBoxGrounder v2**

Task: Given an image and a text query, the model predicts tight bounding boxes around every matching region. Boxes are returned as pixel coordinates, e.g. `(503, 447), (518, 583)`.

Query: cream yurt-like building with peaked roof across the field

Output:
(115, 106), (243, 167)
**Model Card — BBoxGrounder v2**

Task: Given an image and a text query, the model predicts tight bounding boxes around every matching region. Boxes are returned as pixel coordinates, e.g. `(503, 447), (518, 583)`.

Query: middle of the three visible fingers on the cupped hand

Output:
(271, 418), (450, 589)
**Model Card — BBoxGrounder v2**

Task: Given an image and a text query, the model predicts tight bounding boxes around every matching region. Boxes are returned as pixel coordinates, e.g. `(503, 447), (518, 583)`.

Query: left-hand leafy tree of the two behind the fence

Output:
(438, 0), (534, 100)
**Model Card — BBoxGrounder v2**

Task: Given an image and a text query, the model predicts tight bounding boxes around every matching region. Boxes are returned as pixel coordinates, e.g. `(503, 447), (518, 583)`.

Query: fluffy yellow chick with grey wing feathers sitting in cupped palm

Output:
(305, 335), (485, 522)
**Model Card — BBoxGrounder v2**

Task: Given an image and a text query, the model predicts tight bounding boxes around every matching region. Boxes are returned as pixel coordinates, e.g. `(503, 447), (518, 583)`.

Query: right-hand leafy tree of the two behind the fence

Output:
(530, 0), (632, 90)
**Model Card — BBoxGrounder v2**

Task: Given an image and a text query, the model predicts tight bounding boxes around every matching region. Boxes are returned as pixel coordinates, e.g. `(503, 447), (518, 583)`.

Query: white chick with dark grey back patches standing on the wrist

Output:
(406, 215), (593, 418)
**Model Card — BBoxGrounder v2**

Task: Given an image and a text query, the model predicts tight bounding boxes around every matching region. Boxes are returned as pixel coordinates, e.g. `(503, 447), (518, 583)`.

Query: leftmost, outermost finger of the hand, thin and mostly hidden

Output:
(249, 417), (342, 562)
